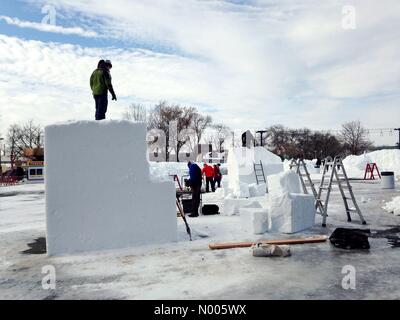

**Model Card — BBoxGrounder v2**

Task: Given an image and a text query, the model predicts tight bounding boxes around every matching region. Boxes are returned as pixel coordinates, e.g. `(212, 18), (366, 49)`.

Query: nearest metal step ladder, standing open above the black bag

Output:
(316, 156), (367, 227)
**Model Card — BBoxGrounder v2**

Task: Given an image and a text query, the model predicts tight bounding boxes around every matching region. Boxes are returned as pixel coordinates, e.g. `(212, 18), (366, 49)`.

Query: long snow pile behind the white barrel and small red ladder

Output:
(343, 149), (400, 178)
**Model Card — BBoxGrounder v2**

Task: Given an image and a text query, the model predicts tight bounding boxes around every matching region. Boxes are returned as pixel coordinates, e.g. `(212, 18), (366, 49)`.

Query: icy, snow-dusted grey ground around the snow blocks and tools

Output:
(0, 181), (400, 299)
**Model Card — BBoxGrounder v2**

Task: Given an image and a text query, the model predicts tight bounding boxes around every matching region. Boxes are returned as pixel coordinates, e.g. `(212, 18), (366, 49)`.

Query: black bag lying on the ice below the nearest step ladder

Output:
(329, 228), (371, 250)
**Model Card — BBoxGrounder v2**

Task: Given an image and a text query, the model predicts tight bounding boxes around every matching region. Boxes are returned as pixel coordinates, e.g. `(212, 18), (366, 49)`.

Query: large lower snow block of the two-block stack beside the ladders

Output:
(269, 193), (316, 233)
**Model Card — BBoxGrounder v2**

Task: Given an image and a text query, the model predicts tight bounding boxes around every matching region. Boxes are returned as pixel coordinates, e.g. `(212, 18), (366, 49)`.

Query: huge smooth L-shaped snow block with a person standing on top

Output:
(45, 121), (177, 255)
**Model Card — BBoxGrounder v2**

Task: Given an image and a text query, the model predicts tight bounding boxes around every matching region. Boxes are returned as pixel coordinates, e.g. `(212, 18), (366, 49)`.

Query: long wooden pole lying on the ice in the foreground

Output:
(209, 236), (328, 250)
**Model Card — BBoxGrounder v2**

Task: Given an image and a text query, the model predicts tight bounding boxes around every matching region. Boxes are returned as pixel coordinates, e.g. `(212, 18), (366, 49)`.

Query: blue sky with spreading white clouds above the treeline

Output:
(0, 0), (400, 144)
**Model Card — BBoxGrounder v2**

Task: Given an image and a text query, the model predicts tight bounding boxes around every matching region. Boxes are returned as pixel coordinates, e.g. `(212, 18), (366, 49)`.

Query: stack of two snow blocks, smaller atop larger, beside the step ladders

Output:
(268, 171), (316, 233)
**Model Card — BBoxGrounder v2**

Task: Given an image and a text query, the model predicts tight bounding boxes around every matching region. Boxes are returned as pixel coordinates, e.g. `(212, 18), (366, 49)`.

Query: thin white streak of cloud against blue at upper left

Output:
(0, 16), (98, 38)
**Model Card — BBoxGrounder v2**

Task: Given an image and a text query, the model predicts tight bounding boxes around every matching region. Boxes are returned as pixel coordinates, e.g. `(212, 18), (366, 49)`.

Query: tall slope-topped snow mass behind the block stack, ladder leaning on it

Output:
(227, 147), (283, 197)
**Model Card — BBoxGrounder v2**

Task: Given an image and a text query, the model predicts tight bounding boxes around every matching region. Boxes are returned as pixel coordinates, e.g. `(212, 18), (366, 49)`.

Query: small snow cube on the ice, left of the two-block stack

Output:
(239, 208), (268, 234)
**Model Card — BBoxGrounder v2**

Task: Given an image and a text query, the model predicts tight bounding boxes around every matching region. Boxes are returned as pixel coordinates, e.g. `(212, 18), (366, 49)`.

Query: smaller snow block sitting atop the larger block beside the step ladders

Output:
(267, 171), (303, 196)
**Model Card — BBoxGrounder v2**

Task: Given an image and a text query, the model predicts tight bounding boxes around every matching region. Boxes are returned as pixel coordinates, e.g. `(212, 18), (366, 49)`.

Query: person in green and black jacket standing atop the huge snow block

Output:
(90, 60), (117, 120)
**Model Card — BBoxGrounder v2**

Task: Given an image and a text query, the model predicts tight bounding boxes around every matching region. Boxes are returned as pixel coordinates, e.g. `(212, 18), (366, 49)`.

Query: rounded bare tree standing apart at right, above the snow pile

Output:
(340, 121), (372, 155)
